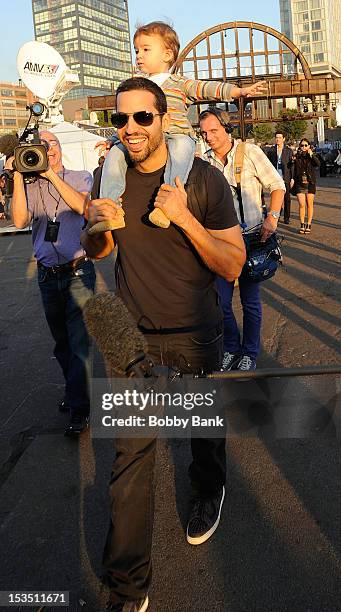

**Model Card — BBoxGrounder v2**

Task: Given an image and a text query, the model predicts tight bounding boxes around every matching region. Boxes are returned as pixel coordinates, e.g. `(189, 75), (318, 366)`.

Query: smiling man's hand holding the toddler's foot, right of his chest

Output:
(155, 176), (191, 227)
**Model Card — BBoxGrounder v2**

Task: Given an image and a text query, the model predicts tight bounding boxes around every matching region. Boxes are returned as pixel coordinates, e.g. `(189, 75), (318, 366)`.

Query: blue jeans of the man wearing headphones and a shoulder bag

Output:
(216, 272), (262, 359)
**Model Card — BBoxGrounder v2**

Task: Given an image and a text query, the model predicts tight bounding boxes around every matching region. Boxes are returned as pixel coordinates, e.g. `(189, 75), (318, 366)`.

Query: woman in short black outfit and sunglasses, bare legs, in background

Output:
(288, 138), (320, 234)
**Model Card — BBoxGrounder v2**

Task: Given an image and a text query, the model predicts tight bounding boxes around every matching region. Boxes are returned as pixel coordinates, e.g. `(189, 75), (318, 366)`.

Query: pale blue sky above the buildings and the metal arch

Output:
(0, 0), (280, 82)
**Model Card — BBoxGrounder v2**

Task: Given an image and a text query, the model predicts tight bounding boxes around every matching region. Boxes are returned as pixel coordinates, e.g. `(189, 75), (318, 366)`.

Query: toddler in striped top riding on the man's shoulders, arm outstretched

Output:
(92, 21), (266, 233)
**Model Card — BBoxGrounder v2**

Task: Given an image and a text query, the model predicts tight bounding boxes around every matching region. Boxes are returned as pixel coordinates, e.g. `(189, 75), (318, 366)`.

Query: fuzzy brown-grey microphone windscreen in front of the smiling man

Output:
(83, 292), (147, 373)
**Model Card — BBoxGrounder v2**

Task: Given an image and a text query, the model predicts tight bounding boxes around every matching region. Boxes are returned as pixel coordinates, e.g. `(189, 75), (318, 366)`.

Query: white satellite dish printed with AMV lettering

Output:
(17, 40), (67, 100)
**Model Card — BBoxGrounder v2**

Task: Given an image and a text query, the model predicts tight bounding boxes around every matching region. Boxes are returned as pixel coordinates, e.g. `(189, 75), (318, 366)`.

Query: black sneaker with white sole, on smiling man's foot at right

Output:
(187, 487), (225, 545)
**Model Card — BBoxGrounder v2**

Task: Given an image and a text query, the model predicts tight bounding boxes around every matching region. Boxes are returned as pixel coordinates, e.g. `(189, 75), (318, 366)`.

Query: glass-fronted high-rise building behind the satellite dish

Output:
(32, 0), (132, 98)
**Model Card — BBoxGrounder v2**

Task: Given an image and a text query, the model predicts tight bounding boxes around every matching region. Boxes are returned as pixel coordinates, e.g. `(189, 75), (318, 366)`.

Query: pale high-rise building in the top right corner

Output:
(279, 0), (341, 77)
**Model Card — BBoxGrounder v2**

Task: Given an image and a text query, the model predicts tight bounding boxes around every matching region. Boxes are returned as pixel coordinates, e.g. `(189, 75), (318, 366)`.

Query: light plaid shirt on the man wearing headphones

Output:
(205, 140), (285, 230)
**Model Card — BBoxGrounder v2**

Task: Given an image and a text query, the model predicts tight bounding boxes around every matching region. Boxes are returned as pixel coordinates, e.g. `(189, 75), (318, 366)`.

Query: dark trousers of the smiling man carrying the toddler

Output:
(103, 324), (226, 603)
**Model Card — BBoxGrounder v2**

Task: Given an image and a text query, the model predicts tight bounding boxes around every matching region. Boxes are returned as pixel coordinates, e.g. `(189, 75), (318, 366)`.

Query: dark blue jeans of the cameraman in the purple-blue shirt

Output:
(38, 260), (96, 415)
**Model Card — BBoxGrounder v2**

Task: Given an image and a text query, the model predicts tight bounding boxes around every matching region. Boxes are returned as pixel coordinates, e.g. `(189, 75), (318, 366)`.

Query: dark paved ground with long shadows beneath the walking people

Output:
(0, 177), (341, 612)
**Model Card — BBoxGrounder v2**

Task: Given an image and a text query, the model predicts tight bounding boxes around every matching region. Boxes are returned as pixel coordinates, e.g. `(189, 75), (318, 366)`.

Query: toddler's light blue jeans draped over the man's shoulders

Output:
(100, 134), (196, 200)
